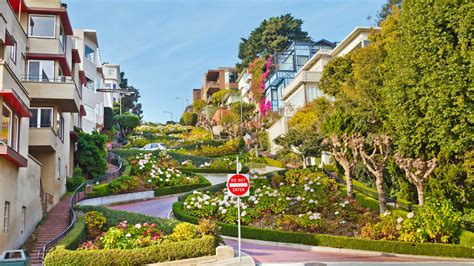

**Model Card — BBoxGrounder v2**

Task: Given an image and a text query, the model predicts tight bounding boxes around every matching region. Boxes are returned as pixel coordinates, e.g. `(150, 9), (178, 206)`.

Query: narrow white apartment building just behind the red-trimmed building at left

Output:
(73, 29), (105, 133)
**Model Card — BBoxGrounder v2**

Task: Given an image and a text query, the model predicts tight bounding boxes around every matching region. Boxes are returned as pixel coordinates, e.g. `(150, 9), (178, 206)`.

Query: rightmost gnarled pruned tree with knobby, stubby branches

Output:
(394, 153), (437, 206)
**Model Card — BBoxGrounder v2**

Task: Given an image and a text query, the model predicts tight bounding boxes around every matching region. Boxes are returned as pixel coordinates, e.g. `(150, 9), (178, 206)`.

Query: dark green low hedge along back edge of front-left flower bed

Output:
(74, 205), (179, 236)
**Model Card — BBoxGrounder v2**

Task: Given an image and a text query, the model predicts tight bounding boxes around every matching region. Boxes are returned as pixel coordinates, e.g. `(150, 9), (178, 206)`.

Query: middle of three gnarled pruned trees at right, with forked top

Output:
(358, 134), (391, 213)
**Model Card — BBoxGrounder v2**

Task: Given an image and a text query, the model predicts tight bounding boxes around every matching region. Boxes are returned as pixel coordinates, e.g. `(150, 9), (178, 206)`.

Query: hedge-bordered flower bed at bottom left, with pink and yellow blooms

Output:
(45, 206), (220, 265)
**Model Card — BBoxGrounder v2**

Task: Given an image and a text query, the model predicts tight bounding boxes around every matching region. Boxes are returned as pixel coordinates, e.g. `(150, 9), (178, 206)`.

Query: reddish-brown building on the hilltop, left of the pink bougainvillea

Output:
(201, 67), (238, 101)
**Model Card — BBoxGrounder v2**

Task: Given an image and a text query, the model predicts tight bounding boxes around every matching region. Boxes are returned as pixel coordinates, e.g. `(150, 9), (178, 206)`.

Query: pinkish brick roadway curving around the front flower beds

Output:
(109, 195), (472, 265)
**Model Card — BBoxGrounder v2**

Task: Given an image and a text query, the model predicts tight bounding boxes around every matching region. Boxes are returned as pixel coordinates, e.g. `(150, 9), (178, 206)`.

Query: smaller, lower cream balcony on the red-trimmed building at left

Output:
(29, 127), (59, 152)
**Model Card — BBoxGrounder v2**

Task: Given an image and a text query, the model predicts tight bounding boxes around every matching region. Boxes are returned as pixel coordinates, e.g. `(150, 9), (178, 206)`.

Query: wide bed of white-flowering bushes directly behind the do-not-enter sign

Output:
(184, 170), (374, 235)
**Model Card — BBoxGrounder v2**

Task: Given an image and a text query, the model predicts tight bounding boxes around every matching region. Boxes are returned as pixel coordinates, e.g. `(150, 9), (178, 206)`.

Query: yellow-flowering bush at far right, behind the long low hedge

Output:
(361, 199), (461, 243)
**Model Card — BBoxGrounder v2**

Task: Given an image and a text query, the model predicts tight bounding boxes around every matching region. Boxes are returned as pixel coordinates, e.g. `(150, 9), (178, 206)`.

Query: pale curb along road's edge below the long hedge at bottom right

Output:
(222, 236), (474, 264)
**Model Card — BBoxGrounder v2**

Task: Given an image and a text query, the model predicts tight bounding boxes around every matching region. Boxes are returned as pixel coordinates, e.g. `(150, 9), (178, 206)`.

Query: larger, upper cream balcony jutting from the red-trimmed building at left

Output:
(23, 76), (81, 113)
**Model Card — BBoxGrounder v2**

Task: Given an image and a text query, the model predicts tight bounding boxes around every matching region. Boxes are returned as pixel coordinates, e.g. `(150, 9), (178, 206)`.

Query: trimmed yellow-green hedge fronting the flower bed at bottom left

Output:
(45, 236), (216, 265)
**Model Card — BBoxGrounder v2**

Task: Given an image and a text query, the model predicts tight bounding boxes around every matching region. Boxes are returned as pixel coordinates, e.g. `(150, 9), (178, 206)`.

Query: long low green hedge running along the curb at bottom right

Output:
(173, 201), (474, 258)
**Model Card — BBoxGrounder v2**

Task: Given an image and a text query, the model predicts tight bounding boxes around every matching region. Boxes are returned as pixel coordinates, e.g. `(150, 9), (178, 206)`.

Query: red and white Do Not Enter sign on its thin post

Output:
(227, 157), (250, 260)
